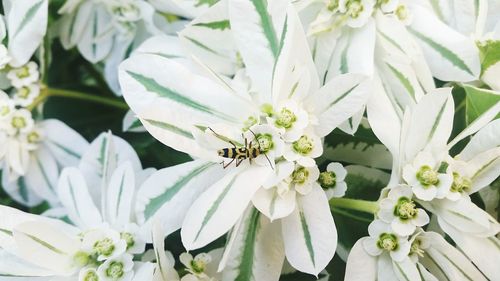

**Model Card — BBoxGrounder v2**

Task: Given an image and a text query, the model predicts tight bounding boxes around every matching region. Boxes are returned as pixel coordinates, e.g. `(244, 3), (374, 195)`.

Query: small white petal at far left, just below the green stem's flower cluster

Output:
(40, 119), (89, 167)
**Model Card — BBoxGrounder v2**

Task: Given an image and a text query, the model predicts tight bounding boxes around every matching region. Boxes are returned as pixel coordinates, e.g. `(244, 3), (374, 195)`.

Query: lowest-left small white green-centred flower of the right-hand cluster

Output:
(363, 220), (411, 262)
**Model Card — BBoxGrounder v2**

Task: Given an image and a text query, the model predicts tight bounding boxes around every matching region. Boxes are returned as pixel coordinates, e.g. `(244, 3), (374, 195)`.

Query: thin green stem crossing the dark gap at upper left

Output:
(27, 88), (129, 110)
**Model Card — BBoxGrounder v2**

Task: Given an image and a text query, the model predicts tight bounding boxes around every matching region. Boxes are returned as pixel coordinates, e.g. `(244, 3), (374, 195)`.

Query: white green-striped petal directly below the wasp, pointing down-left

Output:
(181, 164), (272, 250)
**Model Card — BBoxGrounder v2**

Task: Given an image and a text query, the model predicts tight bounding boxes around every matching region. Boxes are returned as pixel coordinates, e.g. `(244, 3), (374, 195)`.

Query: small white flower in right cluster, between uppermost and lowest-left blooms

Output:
(378, 185), (429, 236)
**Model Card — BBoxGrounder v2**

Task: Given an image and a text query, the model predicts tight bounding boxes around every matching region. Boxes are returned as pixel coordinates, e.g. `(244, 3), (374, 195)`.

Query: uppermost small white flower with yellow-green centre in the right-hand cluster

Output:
(403, 151), (453, 201)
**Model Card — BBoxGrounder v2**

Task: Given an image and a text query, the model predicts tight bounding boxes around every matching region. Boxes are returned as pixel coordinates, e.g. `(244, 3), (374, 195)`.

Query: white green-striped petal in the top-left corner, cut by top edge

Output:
(4, 0), (49, 66)
